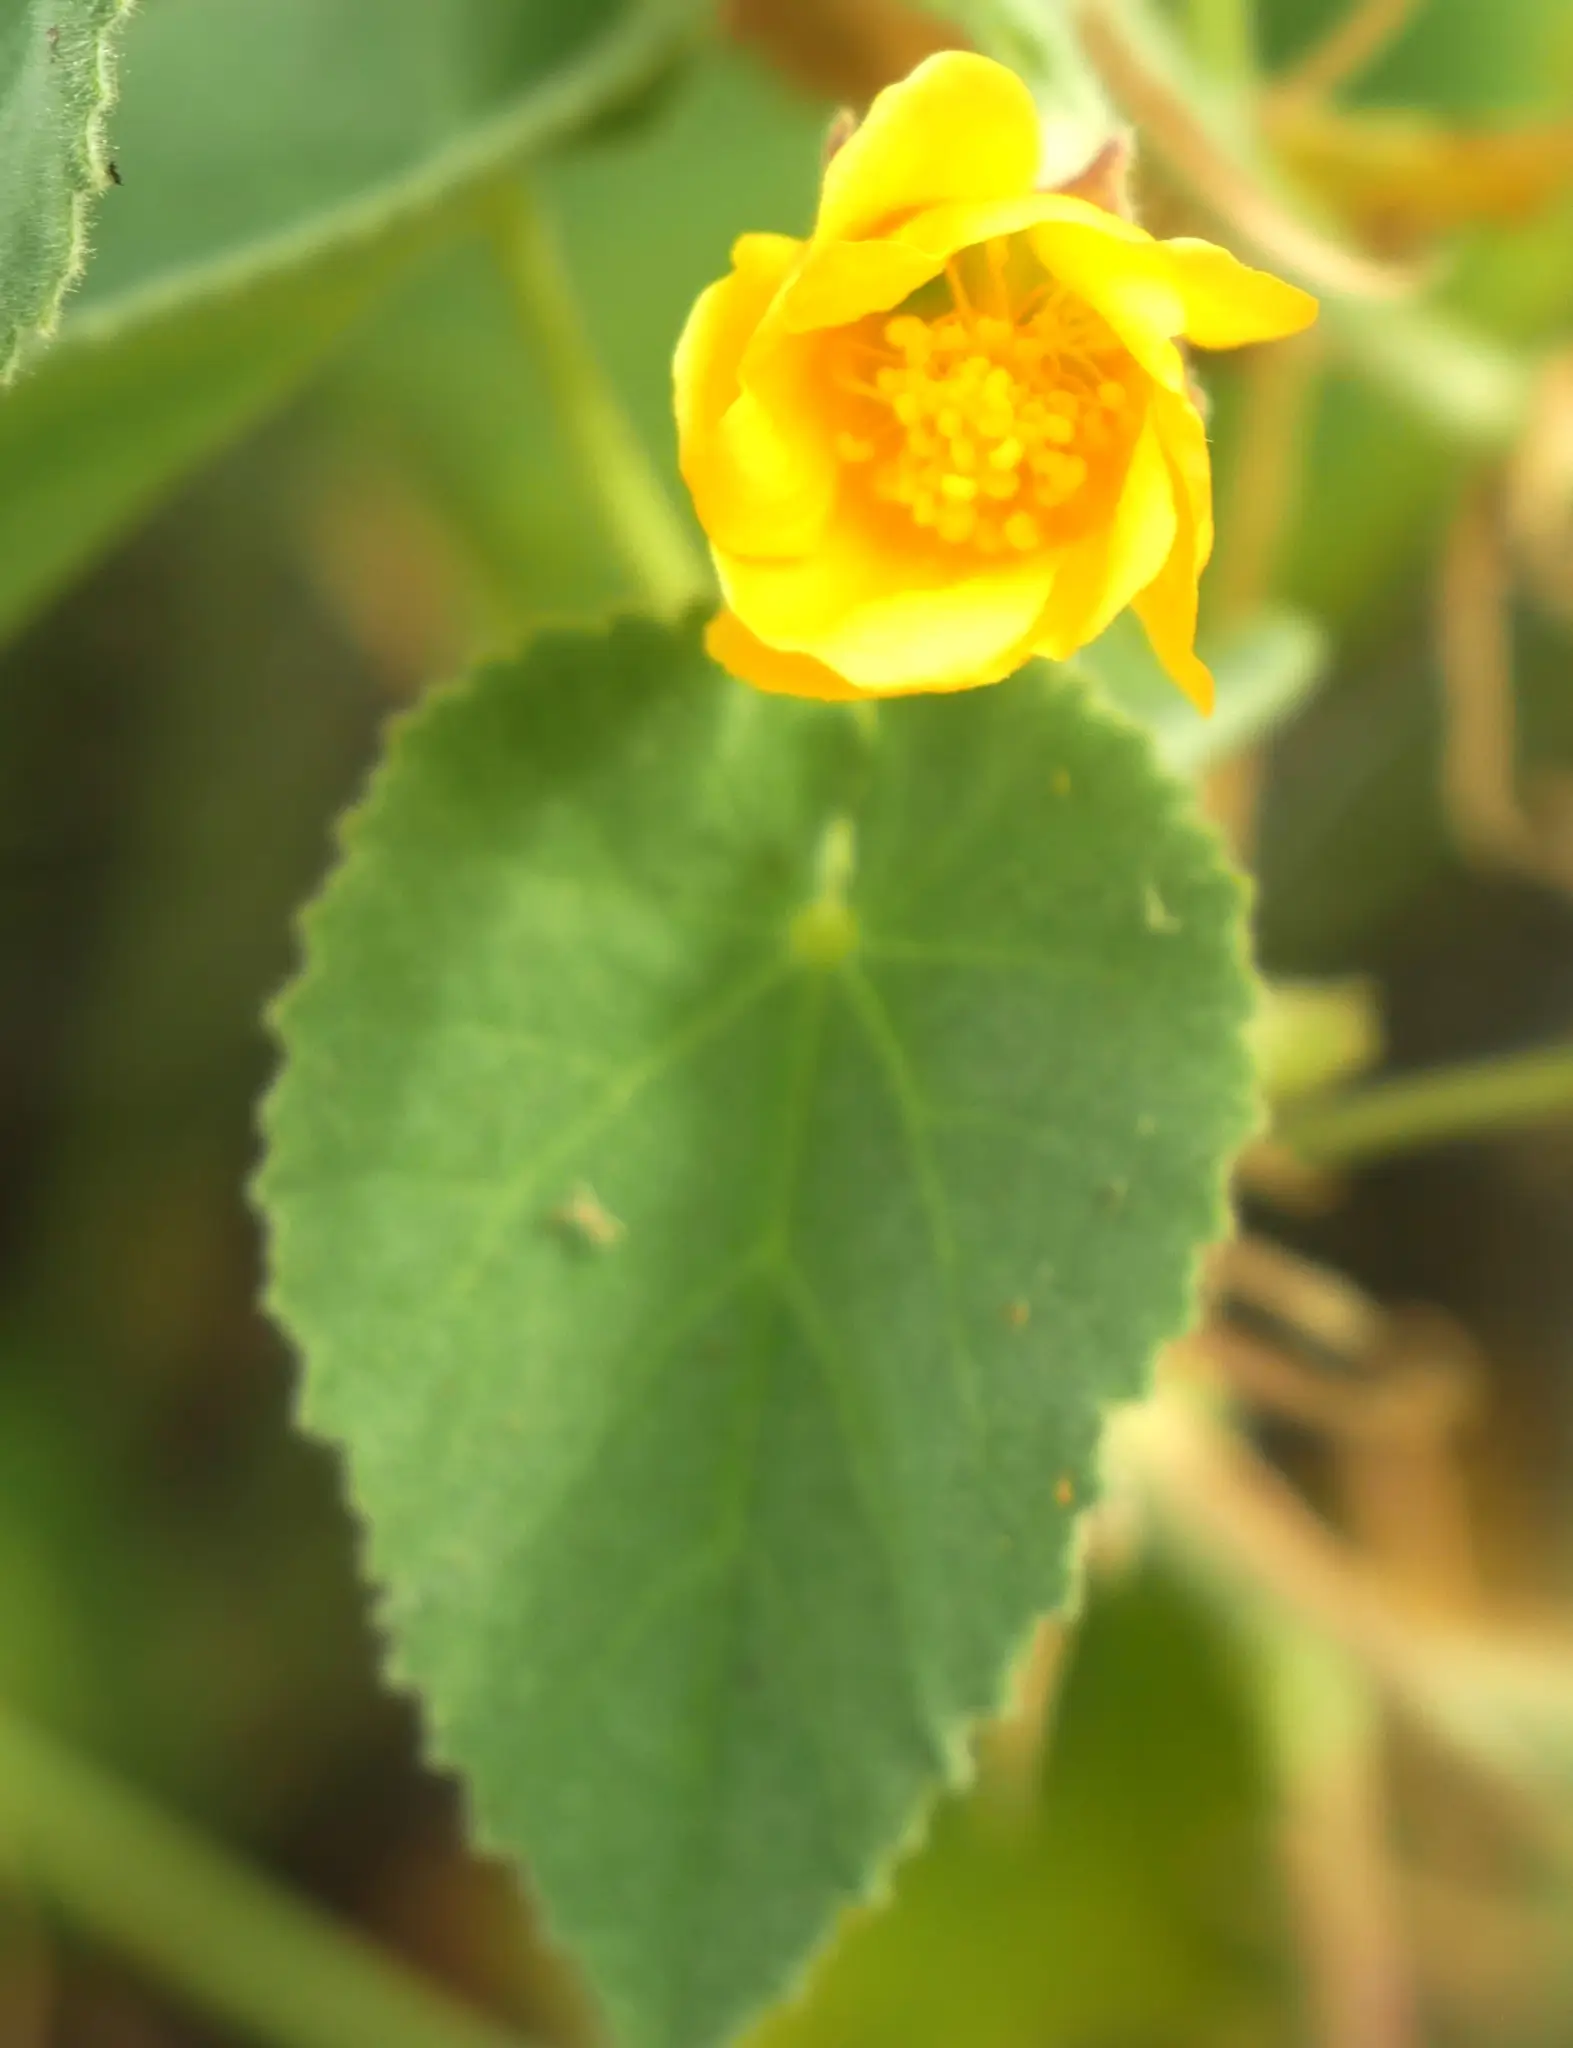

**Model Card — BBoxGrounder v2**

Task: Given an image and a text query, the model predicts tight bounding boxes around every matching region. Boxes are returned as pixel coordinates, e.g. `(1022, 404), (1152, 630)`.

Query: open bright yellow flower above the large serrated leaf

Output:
(676, 51), (1317, 709)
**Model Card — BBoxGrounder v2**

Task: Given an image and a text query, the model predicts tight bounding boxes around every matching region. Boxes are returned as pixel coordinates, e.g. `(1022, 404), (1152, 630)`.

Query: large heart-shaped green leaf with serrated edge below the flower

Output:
(262, 623), (1251, 2048)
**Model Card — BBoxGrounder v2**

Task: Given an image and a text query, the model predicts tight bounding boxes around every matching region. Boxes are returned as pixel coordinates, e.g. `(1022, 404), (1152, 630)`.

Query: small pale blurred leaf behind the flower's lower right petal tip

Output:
(1075, 612), (1327, 774)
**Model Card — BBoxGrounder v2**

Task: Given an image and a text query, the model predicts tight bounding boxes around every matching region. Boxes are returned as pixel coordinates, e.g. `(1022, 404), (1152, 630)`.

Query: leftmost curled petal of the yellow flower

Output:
(674, 236), (838, 555)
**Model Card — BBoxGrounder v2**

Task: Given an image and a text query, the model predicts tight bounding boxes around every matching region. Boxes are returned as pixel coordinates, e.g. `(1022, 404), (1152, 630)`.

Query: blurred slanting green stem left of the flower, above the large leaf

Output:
(494, 180), (711, 618)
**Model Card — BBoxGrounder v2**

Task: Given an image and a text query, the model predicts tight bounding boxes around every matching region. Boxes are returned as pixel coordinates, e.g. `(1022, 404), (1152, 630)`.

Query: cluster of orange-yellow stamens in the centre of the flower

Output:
(836, 264), (1133, 555)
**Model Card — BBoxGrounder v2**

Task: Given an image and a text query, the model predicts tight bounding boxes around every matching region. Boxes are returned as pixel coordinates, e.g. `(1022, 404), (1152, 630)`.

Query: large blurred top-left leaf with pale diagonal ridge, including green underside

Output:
(0, 0), (684, 633)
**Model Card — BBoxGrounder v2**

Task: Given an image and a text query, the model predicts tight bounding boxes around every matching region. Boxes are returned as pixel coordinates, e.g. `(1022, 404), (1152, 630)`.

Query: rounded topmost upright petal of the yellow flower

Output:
(815, 49), (1043, 242)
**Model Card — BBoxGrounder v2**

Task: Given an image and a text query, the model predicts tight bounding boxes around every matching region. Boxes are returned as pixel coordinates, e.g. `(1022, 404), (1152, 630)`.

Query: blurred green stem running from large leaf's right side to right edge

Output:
(1274, 1047), (1573, 1165)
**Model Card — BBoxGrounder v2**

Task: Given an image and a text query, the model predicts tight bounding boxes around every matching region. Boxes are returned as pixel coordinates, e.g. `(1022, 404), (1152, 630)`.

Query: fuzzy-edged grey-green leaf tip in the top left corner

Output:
(0, 0), (131, 381)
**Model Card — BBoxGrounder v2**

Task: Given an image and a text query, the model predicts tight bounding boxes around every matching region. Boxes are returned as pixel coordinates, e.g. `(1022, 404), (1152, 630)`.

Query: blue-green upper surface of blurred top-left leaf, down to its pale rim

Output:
(84, 0), (630, 303)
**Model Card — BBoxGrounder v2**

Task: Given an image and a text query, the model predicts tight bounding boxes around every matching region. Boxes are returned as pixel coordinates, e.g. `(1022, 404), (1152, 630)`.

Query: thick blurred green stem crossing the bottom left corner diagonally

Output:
(0, 1708), (532, 2048)
